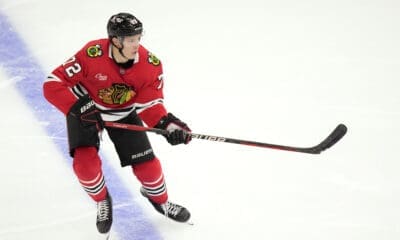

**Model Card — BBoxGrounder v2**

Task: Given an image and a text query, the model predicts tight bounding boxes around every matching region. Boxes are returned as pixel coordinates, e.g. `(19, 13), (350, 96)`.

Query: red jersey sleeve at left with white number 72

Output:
(43, 51), (85, 115)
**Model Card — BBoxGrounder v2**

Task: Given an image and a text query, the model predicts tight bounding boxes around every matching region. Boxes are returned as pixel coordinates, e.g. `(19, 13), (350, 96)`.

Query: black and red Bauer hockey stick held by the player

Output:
(104, 121), (347, 154)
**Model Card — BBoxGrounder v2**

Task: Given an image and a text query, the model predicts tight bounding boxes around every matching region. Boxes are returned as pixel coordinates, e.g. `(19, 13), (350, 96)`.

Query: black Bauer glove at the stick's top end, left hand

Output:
(68, 95), (104, 131)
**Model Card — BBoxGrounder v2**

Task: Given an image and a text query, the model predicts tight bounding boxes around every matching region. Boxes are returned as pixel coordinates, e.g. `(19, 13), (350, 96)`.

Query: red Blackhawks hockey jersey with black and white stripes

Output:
(43, 39), (167, 127)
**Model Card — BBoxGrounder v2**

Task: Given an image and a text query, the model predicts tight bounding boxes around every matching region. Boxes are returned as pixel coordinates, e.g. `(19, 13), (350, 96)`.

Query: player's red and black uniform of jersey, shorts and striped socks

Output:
(43, 39), (168, 203)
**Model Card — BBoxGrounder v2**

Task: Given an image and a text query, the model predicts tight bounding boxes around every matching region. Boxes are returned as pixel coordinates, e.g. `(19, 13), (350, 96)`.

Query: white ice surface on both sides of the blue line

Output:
(0, 0), (400, 240)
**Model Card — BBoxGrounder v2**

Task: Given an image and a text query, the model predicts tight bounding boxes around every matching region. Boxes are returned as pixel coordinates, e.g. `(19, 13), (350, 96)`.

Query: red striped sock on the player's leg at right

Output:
(132, 158), (168, 204)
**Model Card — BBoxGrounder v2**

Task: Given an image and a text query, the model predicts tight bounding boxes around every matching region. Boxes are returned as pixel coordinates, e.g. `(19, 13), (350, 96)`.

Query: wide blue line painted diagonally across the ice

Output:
(0, 12), (162, 240)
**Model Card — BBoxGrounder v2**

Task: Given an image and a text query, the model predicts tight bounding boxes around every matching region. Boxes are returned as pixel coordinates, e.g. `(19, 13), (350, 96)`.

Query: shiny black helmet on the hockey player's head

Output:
(107, 13), (143, 38)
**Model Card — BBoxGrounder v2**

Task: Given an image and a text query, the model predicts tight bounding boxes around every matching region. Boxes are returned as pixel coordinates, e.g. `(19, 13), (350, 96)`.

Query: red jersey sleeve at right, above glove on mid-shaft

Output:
(135, 62), (167, 127)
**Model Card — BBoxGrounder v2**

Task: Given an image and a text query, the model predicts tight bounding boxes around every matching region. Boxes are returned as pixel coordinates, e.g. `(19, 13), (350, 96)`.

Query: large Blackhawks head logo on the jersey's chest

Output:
(98, 84), (136, 104)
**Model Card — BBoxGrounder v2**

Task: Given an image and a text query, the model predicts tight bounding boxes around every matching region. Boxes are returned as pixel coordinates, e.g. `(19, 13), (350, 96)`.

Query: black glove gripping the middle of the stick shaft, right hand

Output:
(155, 113), (192, 145)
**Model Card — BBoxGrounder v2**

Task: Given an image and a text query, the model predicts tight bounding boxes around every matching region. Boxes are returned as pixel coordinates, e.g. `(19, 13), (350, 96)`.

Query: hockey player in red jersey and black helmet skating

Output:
(43, 13), (191, 233)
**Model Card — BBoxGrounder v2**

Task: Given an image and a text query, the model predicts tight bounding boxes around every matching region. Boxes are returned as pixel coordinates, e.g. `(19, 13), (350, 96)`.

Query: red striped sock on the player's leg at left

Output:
(73, 147), (107, 202)
